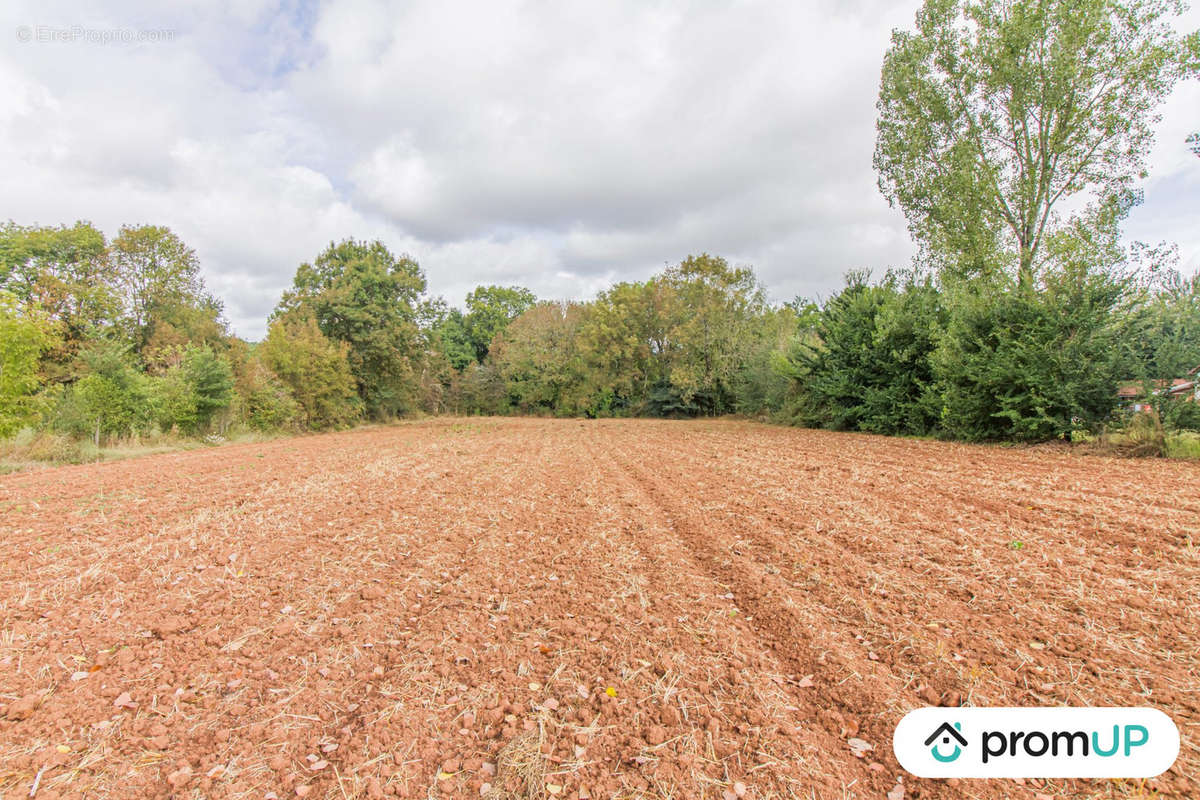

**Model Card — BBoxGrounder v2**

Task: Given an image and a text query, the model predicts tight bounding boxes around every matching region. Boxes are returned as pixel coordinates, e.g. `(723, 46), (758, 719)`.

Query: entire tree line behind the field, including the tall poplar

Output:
(0, 0), (1200, 444)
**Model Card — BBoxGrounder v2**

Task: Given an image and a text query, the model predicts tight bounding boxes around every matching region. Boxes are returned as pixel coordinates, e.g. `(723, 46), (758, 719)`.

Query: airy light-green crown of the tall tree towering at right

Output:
(875, 0), (1200, 285)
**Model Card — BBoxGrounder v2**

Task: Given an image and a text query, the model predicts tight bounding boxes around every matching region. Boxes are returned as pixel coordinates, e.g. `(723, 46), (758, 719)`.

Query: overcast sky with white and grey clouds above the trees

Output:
(0, 0), (1200, 338)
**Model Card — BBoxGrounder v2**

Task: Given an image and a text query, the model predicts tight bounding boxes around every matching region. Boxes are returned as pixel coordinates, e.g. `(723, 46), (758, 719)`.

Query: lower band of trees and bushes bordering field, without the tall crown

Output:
(7, 223), (1200, 441)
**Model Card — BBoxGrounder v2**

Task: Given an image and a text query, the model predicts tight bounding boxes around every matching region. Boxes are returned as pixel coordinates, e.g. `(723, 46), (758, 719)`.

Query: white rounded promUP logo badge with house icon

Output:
(892, 708), (1180, 778)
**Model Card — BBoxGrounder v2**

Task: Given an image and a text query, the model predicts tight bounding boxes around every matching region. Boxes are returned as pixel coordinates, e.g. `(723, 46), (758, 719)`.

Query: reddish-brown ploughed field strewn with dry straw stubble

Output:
(0, 420), (1200, 800)
